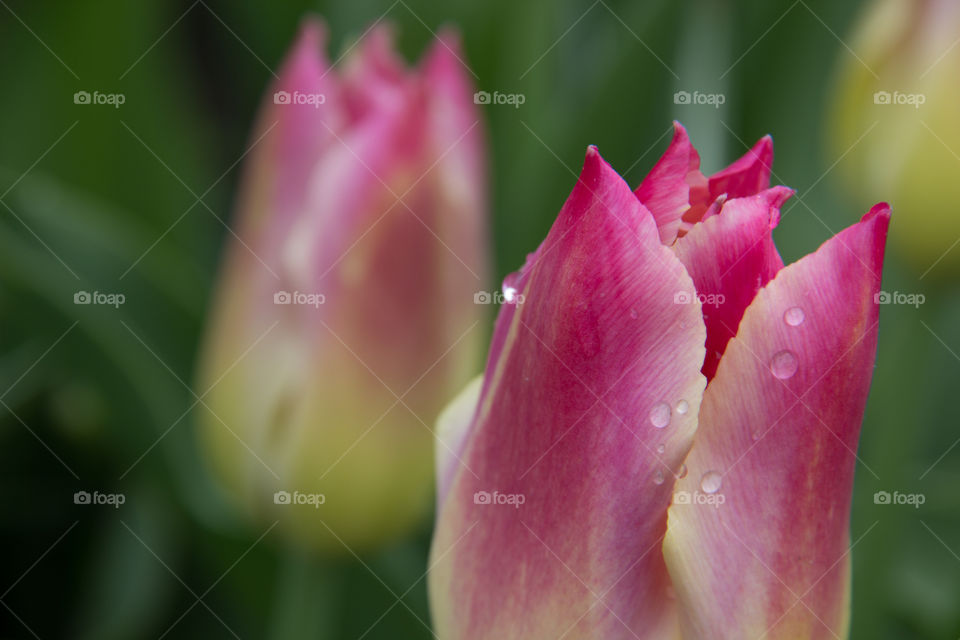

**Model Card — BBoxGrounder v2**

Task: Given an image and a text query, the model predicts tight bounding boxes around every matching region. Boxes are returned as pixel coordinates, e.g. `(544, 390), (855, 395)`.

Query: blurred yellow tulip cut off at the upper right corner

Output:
(829, 0), (960, 275)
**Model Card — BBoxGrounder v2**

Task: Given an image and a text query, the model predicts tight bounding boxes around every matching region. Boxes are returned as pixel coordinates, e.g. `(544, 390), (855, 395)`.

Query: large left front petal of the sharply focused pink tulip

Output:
(429, 148), (705, 640)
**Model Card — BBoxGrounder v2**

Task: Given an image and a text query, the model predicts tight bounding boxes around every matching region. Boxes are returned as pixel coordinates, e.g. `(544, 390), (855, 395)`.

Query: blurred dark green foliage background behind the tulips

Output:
(0, 0), (960, 640)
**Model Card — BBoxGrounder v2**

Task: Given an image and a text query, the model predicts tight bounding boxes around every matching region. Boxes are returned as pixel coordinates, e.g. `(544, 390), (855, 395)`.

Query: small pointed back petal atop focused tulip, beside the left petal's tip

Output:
(634, 122), (707, 245)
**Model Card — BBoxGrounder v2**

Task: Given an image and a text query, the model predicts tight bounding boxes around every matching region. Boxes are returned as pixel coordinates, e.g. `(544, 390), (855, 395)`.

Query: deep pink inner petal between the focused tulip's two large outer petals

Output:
(673, 187), (793, 380)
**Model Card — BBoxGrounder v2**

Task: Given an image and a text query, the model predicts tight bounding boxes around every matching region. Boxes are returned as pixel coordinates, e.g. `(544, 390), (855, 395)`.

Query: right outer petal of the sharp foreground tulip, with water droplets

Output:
(664, 205), (890, 640)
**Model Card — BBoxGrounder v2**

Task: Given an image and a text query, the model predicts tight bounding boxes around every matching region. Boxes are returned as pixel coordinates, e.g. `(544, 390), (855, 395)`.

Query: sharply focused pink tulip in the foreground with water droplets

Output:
(429, 125), (890, 640)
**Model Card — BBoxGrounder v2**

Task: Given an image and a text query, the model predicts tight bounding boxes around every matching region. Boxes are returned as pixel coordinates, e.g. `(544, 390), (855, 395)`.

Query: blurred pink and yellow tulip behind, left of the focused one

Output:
(198, 20), (487, 552)
